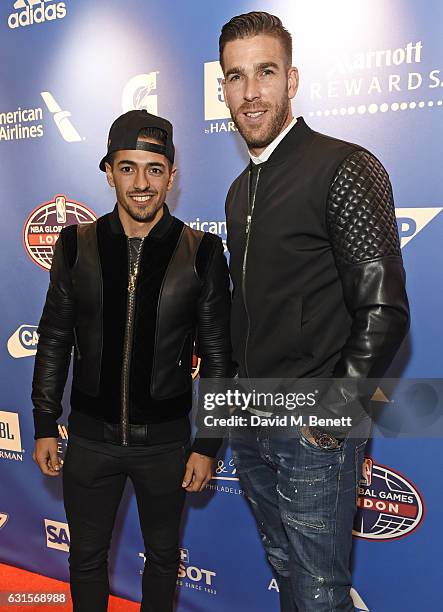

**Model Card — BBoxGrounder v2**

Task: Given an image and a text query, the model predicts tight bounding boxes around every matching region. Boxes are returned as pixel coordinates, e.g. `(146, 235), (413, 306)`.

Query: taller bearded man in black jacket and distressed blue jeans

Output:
(219, 12), (409, 612)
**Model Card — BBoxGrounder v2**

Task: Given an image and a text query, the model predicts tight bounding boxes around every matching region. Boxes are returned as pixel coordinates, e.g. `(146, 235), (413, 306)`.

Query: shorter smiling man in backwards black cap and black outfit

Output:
(32, 110), (231, 612)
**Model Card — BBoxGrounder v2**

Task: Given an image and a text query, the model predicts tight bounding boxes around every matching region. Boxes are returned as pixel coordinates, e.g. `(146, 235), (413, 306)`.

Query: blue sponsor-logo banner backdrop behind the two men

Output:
(0, 0), (443, 612)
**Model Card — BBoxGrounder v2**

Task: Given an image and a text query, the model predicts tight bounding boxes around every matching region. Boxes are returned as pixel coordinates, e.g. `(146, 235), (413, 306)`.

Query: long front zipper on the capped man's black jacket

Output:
(121, 238), (144, 446)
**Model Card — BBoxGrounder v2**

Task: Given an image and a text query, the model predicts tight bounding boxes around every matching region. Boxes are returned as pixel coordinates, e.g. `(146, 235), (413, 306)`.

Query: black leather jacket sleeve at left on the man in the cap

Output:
(32, 231), (74, 439)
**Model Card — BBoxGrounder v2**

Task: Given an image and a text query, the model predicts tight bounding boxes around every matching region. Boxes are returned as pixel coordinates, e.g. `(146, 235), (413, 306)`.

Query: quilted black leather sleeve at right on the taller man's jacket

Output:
(324, 150), (409, 438)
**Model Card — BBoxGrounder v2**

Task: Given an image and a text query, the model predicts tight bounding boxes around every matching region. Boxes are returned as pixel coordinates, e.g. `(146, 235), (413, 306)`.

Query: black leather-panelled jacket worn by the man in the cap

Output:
(32, 204), (233, 456)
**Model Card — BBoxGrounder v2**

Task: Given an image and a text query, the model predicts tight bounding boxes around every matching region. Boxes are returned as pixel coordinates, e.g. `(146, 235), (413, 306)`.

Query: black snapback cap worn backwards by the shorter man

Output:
(99, 109), (175, 172)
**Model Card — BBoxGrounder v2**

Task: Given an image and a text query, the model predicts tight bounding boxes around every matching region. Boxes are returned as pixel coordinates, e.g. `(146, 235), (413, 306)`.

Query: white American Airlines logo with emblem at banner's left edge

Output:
(0, 91), (84, 142)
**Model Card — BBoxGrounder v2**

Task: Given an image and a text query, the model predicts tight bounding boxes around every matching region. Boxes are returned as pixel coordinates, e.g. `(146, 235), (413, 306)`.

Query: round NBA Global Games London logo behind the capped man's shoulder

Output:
(23, 195), (97, 270)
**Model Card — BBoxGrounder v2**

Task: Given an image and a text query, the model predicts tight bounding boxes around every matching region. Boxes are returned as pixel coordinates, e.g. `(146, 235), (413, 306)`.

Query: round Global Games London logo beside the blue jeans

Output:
(353, 457), (424, 540)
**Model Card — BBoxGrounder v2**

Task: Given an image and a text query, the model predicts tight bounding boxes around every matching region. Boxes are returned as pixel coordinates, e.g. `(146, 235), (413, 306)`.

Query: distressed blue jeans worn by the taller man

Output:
(231, 419), (371, 612)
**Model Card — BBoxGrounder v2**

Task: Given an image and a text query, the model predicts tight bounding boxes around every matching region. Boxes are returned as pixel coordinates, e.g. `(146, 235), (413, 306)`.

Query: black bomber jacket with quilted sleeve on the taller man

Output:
(226, 117), (409, 430)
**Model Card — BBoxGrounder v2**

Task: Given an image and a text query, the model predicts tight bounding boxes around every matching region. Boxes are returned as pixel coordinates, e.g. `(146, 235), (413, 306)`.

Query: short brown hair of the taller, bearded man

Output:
(219, 11), (292, 68)
